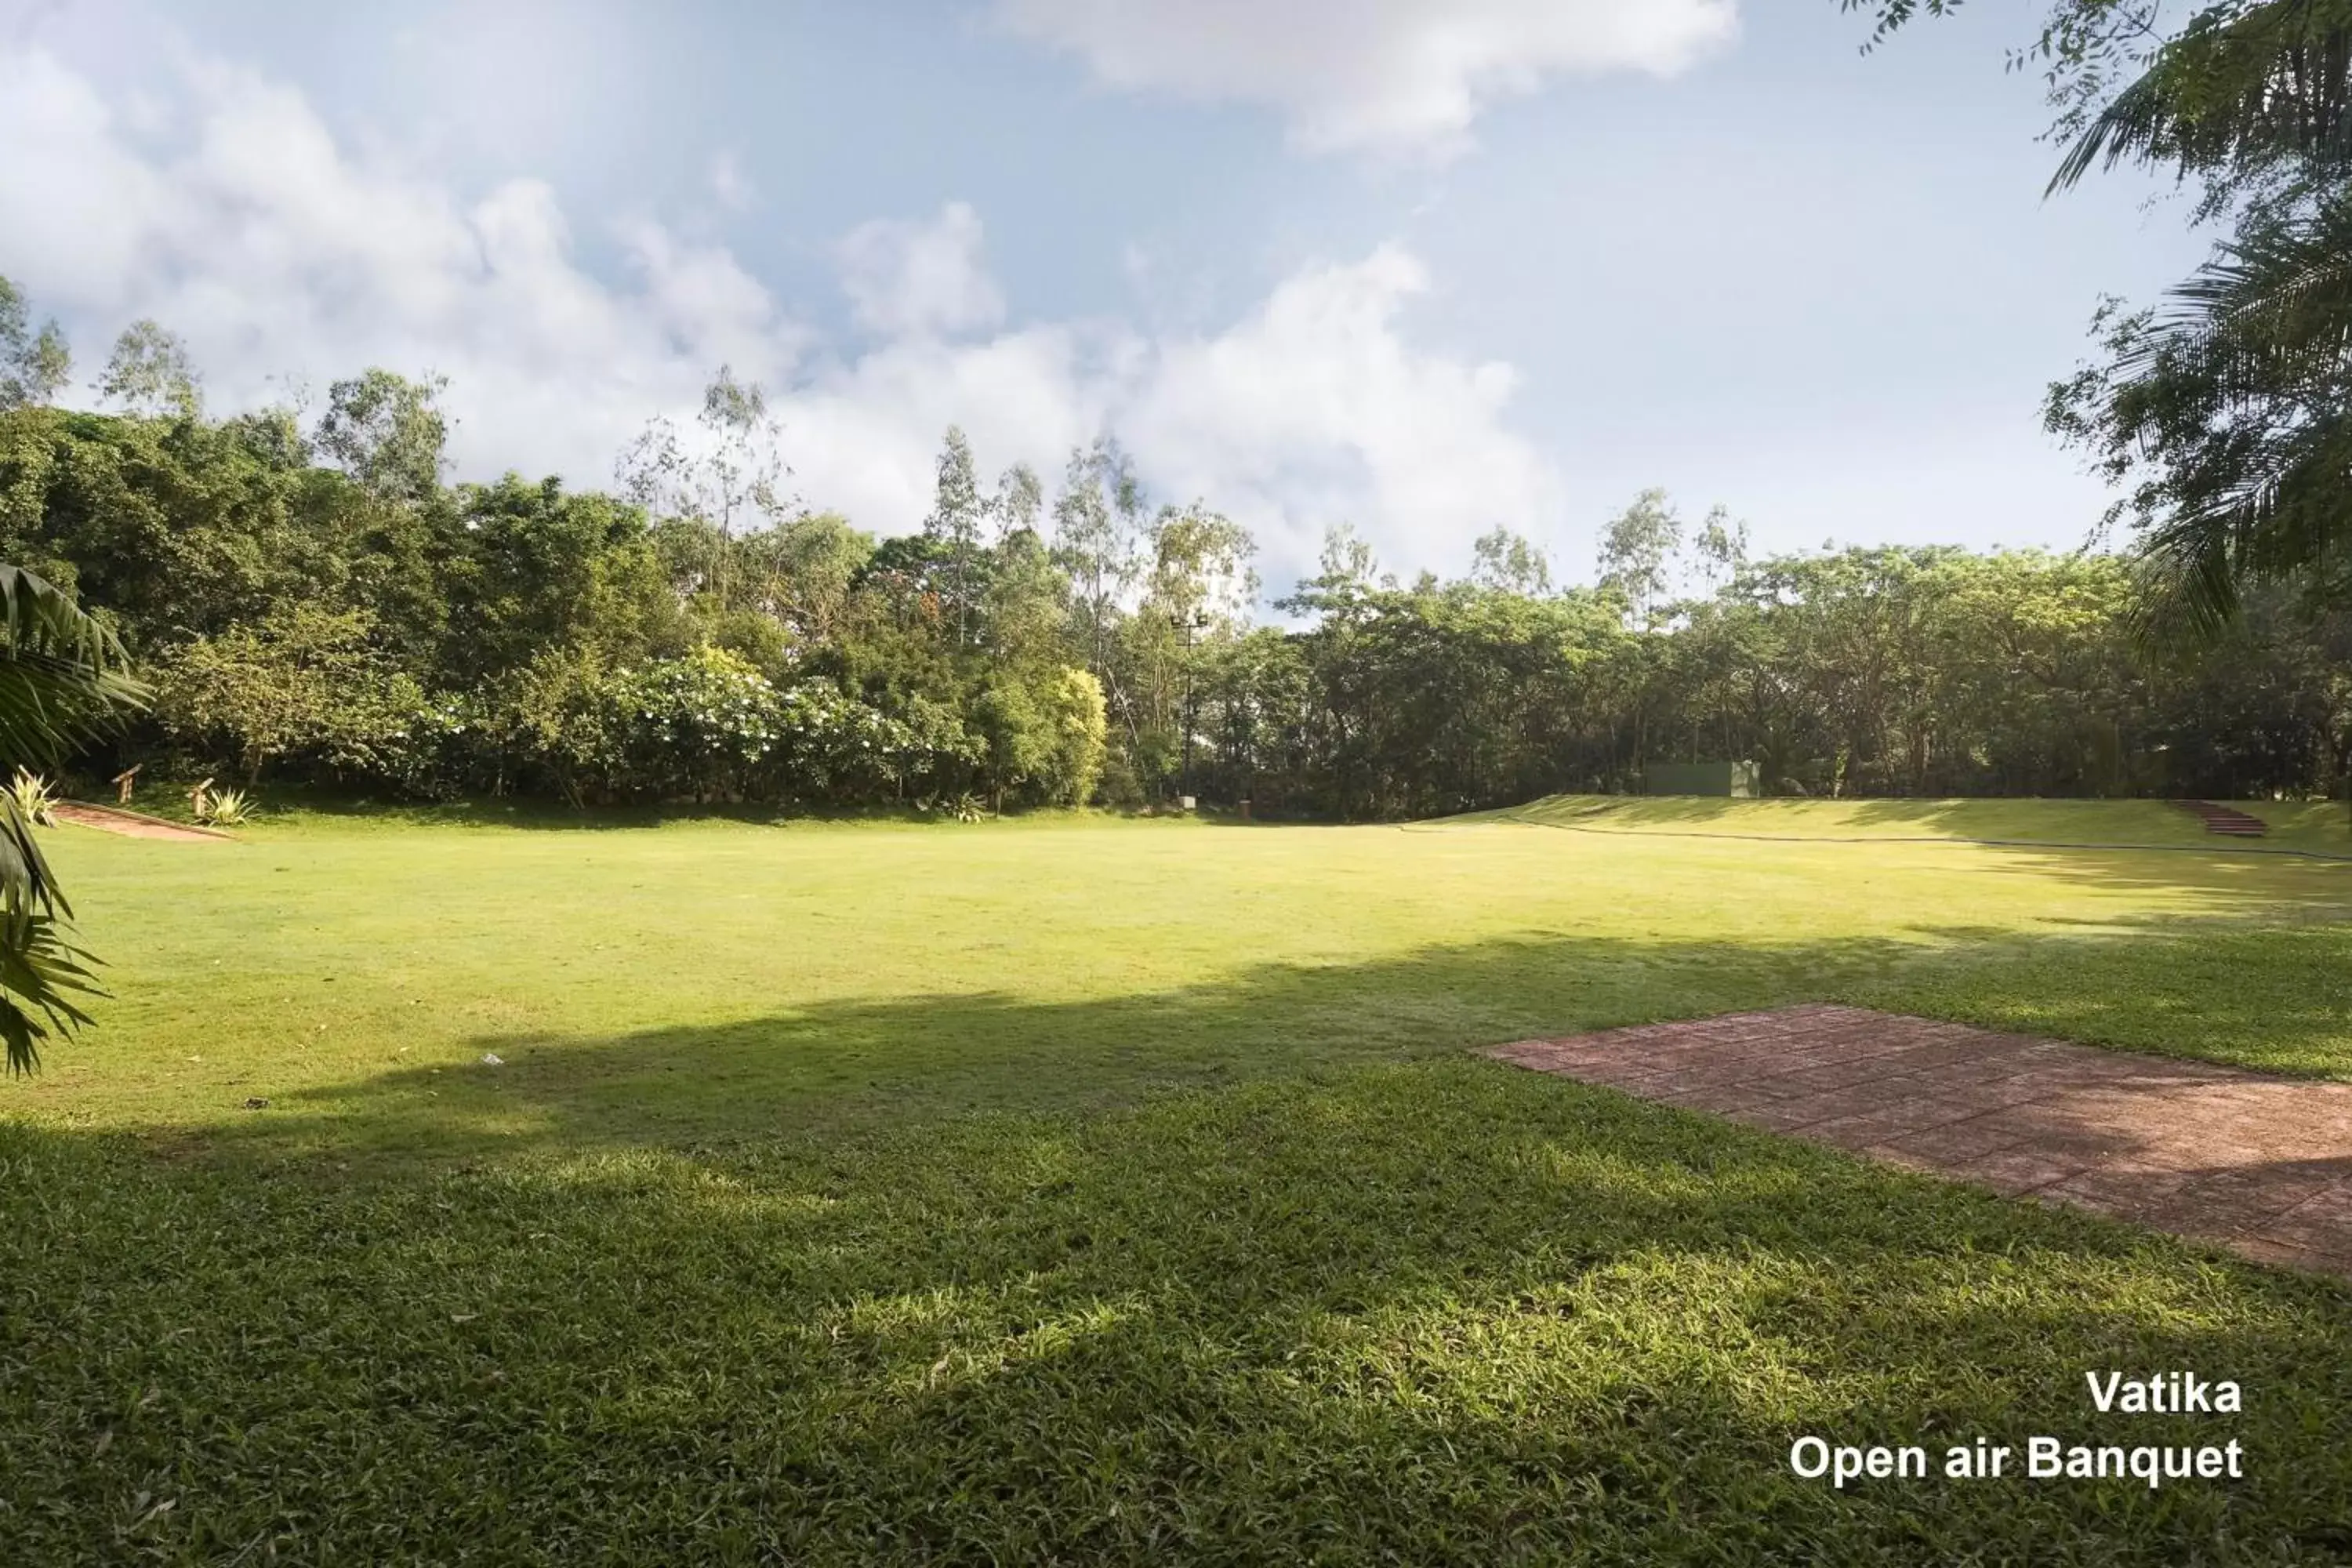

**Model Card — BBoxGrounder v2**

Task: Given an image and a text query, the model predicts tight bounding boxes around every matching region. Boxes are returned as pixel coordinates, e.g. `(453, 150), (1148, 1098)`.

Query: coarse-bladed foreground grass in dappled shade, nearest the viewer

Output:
(0, 1048), (2352, 1566)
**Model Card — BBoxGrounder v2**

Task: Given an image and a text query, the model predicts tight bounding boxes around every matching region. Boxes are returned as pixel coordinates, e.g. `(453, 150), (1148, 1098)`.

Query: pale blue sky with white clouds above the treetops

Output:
(0, 0), (2206, 593)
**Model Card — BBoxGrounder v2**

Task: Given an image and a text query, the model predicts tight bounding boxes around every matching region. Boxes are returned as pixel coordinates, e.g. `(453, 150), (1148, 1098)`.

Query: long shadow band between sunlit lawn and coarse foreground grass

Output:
(170, 921), (2352, 1173)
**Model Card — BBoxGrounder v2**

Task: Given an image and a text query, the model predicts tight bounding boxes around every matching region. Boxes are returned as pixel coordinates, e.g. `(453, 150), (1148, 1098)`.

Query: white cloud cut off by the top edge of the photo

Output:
(995, 0), (1738, 155)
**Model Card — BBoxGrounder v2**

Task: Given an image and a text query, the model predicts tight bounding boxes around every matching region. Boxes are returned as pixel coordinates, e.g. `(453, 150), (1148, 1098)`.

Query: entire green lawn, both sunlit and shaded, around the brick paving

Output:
(0, 801), (2352, 1563)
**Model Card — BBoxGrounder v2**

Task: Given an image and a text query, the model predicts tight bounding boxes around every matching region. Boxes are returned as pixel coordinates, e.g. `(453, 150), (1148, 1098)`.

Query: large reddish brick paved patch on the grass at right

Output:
(1486, 1006), (2352, 1276)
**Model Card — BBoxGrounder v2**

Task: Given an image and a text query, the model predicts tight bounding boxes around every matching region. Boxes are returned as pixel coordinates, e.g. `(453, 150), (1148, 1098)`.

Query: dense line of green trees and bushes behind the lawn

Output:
(0, 285), (2352, 818)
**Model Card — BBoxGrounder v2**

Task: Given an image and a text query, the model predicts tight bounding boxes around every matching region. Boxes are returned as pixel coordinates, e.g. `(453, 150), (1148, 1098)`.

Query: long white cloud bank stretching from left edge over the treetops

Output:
(0, 47), (1557, 586)
